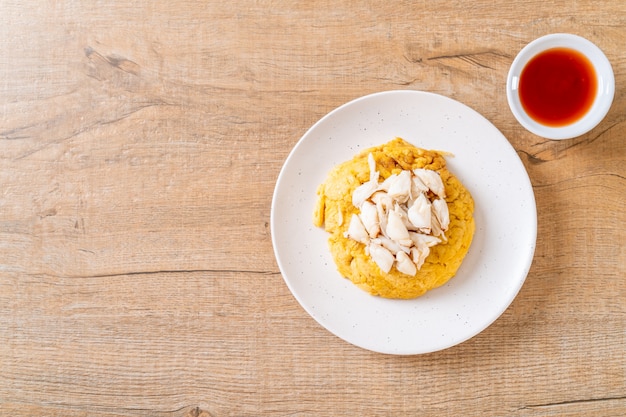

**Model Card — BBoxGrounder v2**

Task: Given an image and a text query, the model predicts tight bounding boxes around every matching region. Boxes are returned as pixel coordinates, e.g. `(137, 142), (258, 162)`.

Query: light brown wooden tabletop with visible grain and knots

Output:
(0, 0), (626, 417)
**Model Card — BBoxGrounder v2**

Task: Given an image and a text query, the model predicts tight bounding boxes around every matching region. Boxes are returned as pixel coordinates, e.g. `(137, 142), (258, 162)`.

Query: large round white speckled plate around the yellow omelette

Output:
(271, 91), (537, 354)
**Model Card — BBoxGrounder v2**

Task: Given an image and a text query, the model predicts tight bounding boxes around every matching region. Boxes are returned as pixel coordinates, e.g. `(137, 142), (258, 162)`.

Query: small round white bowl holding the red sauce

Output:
(506, 33), (615, 139)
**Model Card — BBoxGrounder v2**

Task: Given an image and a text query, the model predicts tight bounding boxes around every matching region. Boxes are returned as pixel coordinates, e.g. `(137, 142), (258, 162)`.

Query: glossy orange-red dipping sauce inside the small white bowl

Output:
(518, 48), (598, 127)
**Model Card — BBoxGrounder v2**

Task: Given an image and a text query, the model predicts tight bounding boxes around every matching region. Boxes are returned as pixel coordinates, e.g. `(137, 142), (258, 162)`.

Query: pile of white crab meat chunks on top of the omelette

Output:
(344, 153), (450, 276)
